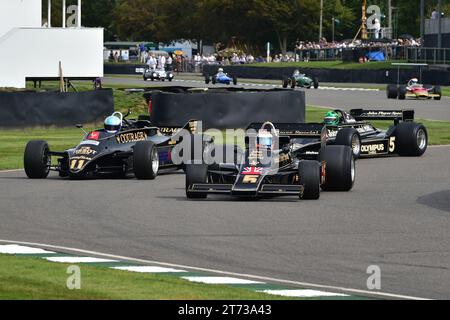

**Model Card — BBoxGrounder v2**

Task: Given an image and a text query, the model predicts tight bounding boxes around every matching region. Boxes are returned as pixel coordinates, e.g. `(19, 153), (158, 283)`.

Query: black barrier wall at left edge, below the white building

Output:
(0, 89), (114, 128)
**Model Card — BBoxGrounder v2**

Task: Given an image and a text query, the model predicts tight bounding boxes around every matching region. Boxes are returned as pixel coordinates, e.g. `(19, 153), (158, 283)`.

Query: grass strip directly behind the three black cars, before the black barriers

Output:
(0, 107), (450, 170)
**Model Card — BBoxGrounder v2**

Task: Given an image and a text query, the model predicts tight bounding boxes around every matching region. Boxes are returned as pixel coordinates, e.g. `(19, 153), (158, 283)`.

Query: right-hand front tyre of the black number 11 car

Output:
(133, 141), (159, 180)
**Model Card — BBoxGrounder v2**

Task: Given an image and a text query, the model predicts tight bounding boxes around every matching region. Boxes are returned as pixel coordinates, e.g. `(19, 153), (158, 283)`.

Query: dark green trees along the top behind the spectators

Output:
(43, 0), (450, 52)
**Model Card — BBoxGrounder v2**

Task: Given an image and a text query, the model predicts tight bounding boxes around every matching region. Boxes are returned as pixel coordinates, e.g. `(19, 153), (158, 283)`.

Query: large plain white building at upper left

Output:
(0, 0), (103, 88)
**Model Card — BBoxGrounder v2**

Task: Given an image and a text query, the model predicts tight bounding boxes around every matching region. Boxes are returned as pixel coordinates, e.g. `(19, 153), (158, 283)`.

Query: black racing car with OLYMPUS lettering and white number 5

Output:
(324, 109), (428, 158)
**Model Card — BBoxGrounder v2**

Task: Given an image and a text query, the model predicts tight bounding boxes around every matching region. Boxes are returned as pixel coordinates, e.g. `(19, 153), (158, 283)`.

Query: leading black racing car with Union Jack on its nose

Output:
(186, 122), (356, 199)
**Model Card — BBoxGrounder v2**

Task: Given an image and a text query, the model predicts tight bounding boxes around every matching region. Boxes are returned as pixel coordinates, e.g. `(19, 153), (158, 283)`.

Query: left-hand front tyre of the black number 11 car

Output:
(23, 140), (51, 179)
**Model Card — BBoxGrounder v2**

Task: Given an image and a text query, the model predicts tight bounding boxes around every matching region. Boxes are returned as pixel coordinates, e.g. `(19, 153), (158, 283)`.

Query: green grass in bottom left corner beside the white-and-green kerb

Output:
(0, 255), (286, 300)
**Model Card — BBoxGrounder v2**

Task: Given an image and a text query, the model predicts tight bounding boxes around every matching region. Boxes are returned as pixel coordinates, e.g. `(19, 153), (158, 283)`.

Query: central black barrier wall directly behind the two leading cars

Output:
(151, 89), (305, 130)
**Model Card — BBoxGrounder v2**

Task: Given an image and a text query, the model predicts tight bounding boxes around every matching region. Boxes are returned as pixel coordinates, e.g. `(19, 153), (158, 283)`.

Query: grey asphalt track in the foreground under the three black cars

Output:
(0, 147), (450, 299)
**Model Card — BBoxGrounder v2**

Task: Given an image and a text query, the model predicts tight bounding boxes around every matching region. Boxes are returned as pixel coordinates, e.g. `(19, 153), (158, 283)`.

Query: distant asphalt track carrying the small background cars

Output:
(104, 76), (450, 121)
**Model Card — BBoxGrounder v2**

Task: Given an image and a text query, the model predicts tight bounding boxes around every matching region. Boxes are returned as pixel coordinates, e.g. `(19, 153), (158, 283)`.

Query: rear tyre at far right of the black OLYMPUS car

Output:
(395, 122), (428, 157)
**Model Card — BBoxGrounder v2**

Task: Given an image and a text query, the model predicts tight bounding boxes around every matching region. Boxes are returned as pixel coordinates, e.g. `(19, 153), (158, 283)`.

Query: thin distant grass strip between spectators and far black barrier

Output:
(245, 61), (406, 70)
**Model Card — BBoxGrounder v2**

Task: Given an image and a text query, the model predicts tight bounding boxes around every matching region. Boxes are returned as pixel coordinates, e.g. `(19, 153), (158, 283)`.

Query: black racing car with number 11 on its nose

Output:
(24, 112), (197, 180)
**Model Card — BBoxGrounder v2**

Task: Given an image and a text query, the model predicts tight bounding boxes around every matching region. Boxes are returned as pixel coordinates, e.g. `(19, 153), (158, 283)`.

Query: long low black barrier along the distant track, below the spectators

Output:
(203, 65), (450, 85)
